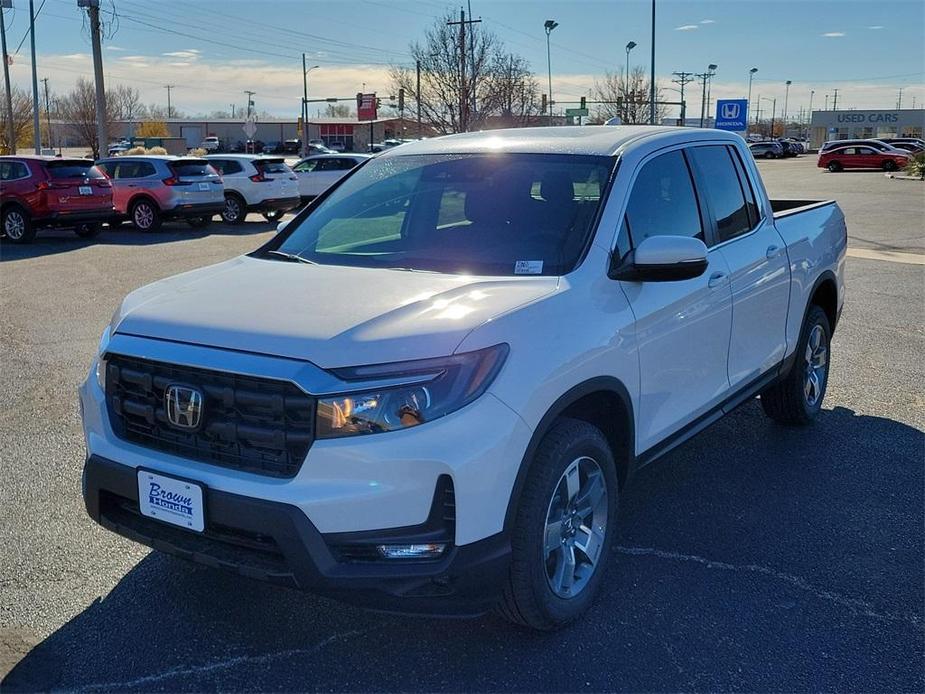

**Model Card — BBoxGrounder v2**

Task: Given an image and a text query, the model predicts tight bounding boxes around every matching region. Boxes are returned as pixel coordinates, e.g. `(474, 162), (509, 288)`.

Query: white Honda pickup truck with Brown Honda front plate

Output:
(80, 126), (846, 629)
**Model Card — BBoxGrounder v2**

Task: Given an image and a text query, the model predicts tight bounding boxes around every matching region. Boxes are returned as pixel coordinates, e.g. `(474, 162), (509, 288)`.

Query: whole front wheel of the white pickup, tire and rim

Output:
(499, 419), (619, 630)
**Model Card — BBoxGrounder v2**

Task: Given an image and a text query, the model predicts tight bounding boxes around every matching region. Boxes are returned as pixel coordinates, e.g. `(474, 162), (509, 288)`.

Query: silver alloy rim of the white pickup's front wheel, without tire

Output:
(543, 456), (608, 599)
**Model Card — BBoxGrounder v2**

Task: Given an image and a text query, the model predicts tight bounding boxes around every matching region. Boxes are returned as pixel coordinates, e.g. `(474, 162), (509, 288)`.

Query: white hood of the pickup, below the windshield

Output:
(112, 256), (558, 368)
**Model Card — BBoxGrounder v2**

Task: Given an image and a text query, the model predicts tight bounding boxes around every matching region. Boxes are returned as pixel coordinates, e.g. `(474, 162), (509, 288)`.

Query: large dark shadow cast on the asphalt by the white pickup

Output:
(2, 403), (925, 692)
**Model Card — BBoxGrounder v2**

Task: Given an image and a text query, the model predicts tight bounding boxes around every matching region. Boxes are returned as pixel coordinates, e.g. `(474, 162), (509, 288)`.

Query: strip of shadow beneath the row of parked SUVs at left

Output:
(0, 221), (276, 263)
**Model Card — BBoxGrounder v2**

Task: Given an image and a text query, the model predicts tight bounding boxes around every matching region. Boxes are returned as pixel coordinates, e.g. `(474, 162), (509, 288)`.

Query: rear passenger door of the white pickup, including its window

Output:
(689, 144), (790, 391)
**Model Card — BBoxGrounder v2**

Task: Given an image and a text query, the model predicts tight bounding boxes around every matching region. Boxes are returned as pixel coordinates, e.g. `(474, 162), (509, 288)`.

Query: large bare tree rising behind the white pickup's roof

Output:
(390, 12), (537, 134)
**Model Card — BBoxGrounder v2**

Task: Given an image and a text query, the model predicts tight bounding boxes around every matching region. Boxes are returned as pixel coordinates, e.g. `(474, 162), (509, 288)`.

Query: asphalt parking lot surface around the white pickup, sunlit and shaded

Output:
(0, 156), (925, 691)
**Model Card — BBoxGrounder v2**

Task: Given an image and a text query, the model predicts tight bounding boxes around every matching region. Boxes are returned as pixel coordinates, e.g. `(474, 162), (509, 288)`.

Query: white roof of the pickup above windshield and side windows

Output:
(379, 125), (741, 157)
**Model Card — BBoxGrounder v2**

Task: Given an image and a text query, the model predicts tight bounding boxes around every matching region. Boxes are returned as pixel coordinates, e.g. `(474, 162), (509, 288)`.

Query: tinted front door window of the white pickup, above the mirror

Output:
(621, 150), (703, 246)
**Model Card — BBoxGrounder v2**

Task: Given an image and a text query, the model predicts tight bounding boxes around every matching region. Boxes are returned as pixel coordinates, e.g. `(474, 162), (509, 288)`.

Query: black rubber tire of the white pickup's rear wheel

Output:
(761, 305), (832, 425)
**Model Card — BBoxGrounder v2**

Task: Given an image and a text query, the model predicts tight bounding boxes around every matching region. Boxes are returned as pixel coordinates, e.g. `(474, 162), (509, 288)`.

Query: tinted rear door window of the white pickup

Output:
(688, 145), (751, 242)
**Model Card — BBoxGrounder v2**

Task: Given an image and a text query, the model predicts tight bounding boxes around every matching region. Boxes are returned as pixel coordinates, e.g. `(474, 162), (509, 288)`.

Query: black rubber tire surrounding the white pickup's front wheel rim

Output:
(498, 419), (619, 631)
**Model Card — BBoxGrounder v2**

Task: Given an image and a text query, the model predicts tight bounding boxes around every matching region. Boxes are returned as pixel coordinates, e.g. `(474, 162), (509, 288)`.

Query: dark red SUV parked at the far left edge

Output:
(0, 155), (113, 243)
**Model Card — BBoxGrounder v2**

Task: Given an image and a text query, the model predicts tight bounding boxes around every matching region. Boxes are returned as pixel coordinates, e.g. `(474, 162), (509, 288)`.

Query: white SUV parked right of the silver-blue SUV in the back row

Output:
(205, 154), (301, 224)
